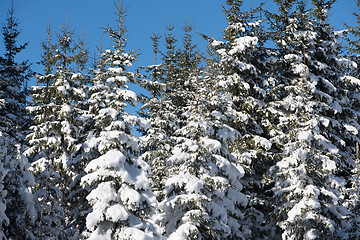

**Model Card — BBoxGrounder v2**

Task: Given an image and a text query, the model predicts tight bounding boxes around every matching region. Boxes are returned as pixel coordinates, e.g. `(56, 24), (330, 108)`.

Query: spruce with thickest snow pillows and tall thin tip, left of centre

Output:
(81, 3), (156, 240)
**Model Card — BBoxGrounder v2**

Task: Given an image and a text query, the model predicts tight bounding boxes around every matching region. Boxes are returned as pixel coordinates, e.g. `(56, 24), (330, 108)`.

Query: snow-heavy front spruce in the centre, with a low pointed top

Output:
(158, 43), (248, 239)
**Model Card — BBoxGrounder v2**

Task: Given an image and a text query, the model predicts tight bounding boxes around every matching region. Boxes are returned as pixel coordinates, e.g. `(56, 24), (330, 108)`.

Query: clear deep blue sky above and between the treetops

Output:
(0, 0), (356, 84)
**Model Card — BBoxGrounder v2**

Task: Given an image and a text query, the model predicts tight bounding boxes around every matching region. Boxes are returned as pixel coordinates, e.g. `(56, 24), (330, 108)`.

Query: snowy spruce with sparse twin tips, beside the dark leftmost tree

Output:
(26, 19), (86, 239)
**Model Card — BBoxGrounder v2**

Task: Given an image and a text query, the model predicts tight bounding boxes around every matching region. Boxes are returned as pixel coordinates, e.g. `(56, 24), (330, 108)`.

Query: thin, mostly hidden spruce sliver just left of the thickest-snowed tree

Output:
(67, 28), (91, 239)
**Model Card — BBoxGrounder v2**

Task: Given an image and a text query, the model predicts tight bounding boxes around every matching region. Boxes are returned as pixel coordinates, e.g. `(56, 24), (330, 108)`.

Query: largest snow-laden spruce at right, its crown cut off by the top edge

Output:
(264, 0), (360, 239)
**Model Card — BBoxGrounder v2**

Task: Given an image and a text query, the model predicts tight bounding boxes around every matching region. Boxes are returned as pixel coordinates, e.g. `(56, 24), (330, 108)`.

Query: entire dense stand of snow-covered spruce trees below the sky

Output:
(0, 0), (360, 240)
